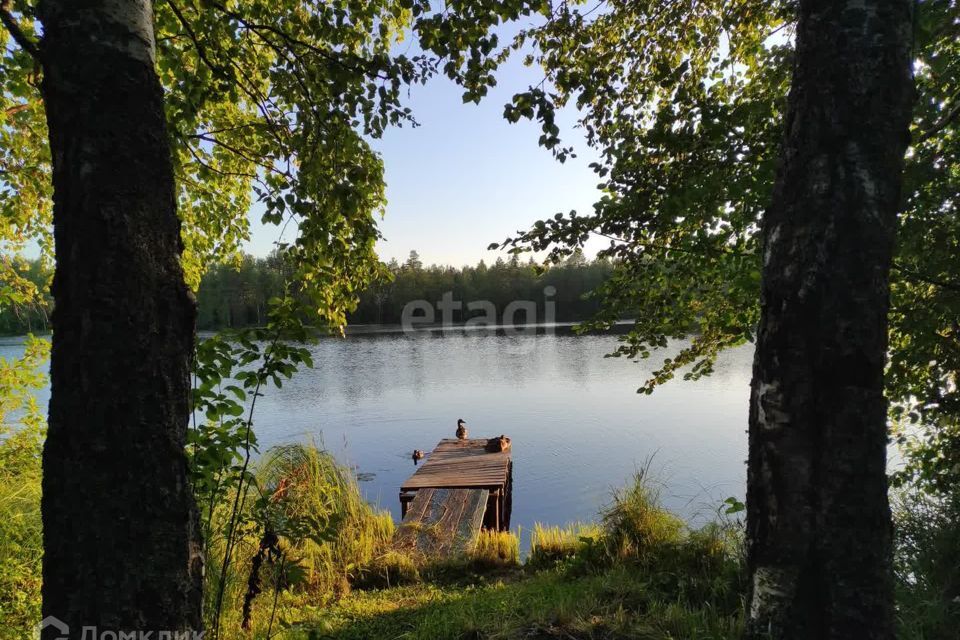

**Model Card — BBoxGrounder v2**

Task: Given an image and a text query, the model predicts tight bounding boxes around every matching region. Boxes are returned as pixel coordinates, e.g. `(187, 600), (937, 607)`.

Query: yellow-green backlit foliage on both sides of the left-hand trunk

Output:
(0, 0), (549, 326)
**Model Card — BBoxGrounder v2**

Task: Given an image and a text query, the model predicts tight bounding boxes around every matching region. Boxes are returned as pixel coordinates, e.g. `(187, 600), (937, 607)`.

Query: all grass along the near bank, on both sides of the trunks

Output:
(0, 434), (960, 640)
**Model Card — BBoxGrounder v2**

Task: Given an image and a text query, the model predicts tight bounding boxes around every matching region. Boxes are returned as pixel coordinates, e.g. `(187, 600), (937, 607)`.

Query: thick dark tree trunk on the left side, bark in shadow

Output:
(38, 0), (202, 638)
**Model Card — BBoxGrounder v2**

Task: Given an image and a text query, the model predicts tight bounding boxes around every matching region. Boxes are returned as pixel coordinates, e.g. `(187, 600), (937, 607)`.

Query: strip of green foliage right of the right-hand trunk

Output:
(886, 0), (960, 495)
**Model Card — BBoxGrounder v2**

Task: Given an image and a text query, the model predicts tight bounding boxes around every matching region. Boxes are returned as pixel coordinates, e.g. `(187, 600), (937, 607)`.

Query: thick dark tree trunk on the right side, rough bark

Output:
(747, 0), (913, 640)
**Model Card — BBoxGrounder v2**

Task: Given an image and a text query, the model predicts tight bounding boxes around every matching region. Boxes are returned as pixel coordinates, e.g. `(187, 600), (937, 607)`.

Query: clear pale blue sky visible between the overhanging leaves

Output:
(240, 50), (604, 266)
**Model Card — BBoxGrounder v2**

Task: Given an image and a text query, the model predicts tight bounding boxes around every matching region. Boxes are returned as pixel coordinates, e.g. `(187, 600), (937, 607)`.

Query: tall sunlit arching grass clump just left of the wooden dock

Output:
(205, 444), (394, 637)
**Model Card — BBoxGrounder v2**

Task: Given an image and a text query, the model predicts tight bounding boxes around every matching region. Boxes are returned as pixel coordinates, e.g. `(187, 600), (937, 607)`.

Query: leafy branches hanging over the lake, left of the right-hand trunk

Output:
(492, 0), (791, 392)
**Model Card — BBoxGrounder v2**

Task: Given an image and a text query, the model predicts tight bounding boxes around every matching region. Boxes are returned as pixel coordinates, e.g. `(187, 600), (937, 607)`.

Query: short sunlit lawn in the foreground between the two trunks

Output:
(285, 567), (741, 640)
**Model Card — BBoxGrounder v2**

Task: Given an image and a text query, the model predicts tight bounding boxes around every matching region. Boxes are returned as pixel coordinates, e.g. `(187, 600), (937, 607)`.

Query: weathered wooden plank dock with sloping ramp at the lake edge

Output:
(395, 439), (513, 556)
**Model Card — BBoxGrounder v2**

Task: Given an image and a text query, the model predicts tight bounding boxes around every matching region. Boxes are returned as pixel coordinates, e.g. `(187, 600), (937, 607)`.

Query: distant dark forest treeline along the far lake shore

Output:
(0, 251), (613, 335)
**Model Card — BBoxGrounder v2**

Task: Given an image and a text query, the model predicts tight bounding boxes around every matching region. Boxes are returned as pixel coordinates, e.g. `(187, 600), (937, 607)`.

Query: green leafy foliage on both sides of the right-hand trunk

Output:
(488, 0), (960, 491)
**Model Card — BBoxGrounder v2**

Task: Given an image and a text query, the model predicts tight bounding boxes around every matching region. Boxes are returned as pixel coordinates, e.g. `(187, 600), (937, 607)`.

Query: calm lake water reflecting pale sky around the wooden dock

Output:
(0, 332), (753, 542)
